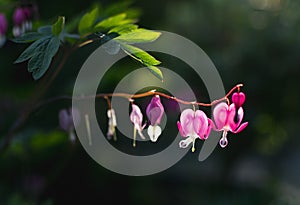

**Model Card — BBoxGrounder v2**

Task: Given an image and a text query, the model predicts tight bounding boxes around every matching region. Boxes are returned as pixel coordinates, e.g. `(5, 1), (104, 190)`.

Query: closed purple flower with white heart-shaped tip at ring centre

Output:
(146, 95), (164, 142)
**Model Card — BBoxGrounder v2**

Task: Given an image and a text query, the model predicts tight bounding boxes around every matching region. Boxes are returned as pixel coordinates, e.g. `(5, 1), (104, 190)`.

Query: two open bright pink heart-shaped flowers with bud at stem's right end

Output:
(177, 92), (248, 152)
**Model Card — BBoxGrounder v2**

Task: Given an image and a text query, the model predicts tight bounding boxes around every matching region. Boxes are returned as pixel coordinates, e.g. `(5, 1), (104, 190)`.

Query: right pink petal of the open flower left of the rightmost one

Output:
(193, 110), (208, 139)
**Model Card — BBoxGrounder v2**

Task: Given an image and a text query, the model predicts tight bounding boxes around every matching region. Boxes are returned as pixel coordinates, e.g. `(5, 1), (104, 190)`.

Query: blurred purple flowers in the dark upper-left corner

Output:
(0, 5), (37, 47)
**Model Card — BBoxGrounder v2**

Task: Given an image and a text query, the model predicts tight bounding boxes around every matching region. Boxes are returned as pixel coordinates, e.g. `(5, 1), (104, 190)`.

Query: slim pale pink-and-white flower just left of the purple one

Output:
(130, 104), (146, 147)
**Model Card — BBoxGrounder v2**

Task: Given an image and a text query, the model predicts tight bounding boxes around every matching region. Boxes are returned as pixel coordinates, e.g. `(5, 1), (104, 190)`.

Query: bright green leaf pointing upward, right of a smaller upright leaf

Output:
(78, 7), (99, 35)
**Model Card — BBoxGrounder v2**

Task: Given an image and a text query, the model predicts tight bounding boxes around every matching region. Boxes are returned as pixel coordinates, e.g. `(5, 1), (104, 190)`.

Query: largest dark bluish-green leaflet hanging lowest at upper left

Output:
(30, 37), (60, 80)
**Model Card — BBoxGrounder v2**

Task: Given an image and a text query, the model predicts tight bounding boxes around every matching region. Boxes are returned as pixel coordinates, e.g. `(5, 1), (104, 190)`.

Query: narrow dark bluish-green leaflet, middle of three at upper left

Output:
(14, 36), (50, 63)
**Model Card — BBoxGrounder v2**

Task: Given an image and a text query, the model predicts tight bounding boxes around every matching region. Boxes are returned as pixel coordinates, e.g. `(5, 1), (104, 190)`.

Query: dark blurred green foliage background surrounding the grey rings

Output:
(0, 0), (300, 205)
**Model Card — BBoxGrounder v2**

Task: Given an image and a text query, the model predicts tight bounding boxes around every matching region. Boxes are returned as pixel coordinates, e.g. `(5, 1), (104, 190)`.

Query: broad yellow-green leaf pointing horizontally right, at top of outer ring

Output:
(115, 28), (161, 43)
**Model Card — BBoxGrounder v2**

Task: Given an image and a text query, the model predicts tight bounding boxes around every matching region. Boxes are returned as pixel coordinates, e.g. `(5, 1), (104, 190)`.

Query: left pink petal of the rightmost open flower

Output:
(213, 102), (228, 130)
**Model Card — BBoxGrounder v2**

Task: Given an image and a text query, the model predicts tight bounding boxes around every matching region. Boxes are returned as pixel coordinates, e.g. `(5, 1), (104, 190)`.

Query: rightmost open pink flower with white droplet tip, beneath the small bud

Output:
(213, 102), (248, 148)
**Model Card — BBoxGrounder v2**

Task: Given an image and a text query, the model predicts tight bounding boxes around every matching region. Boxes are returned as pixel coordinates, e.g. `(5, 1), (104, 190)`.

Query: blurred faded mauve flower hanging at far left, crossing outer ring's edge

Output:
(58, 108), (80, 143)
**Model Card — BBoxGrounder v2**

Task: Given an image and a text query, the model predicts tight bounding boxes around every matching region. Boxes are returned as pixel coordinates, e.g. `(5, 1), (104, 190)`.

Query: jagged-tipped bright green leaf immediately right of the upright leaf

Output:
(95, 13), (135, 31)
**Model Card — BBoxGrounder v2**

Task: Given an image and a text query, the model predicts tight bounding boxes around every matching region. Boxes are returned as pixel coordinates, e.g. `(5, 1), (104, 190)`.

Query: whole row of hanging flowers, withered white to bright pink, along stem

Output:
(102, 90), (248, 152)
